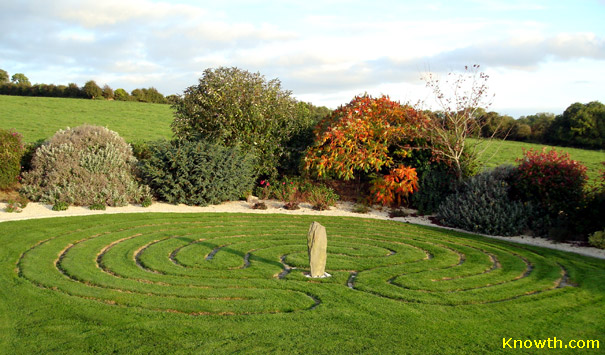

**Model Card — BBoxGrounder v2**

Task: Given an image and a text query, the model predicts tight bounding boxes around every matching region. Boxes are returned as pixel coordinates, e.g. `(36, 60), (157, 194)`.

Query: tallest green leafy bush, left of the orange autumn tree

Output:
(172, 67), (304, 176)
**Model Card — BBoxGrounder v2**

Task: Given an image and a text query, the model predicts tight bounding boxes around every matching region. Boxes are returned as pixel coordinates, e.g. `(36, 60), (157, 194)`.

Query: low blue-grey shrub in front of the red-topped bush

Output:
(437, 166), (532, 236)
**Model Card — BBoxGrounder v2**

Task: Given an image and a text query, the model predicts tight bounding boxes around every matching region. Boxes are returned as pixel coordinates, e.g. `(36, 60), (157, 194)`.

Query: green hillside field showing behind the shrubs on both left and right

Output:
(0, 95), (605, 181)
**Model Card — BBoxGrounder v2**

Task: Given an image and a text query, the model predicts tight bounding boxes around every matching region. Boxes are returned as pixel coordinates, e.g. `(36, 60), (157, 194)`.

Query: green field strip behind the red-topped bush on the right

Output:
(471, 140), (605, 185)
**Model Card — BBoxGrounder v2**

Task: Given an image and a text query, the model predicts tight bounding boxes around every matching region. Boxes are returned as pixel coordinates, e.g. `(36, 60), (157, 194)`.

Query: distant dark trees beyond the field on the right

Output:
(479, 101), (605, 149)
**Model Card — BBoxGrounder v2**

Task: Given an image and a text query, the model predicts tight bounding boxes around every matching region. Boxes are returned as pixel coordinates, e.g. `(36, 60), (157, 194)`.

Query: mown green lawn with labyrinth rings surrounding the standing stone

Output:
(0, 213), (605, 354)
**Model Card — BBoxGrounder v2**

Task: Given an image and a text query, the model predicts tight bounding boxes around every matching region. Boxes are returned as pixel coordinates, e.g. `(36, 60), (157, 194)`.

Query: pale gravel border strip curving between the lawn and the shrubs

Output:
(0, 201), (605, 259)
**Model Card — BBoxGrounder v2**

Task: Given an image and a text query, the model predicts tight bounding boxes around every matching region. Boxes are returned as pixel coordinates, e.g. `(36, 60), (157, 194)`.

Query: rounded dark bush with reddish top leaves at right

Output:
(512, 148), (587, 216)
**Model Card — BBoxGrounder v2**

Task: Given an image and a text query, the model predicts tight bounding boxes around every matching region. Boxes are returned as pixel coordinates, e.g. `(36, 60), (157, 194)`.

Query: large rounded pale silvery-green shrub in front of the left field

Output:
(22, 125), (149, 206)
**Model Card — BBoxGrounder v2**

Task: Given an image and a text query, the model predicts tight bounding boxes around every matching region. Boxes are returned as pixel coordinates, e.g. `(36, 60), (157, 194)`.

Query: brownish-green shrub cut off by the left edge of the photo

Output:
(0, 129), (25, 189)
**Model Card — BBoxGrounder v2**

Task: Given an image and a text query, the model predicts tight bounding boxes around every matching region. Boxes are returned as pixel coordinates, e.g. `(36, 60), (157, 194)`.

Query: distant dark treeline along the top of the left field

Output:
(0, 69), (178, 104)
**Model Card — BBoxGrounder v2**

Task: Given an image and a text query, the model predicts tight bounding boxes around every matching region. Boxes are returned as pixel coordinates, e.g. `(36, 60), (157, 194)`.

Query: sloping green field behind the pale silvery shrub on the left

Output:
(0, 95), (172, 142)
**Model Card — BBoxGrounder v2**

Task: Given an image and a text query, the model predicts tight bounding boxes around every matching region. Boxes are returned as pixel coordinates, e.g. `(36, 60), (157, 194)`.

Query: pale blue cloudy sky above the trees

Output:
(0, 0), (605, 117)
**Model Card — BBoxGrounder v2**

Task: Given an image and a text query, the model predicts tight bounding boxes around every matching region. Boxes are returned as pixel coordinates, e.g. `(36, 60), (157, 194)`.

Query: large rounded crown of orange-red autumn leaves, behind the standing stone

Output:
(305, 95), (428, 180)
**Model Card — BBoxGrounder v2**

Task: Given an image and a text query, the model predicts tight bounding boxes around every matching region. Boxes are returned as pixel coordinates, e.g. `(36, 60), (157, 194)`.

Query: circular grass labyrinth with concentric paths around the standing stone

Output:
(0, 214), (605, 354)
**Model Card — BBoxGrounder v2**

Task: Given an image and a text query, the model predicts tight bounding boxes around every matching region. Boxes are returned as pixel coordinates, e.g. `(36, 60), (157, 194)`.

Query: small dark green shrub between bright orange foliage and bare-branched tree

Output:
(412, 165), (458, 214)
